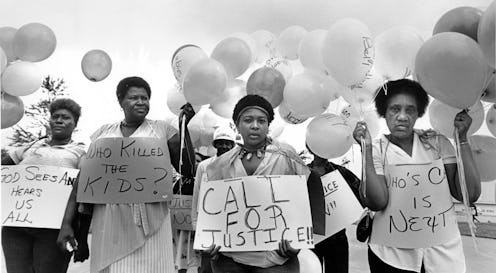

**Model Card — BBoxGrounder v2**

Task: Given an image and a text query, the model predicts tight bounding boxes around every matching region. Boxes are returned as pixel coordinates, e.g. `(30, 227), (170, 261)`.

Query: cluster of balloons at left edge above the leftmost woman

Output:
(0, 23), (57, 129)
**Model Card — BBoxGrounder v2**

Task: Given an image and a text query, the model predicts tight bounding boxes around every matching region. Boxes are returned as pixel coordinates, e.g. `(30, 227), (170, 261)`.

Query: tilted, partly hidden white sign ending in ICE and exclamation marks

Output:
(315, 171), (363, 242)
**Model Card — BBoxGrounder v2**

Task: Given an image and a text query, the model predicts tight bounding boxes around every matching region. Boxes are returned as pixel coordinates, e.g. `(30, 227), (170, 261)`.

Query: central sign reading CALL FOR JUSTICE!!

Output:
(194, 175), (314, 252)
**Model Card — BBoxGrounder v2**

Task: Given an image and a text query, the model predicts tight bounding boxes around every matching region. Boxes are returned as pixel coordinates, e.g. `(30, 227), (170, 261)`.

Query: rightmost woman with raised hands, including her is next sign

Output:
(353, 79), (480, 272)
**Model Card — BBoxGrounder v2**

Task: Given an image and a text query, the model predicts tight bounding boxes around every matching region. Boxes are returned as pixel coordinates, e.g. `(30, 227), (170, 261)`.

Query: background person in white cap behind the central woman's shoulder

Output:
(191, 126), (236, 273)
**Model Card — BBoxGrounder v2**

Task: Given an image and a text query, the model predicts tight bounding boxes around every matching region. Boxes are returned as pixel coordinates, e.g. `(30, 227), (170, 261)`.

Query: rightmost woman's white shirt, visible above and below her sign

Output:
(369, 133), (466, 273)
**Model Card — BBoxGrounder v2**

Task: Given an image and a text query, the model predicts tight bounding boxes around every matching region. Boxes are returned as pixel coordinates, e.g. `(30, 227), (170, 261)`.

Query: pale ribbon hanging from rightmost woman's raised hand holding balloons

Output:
(455, 128), (479, 252)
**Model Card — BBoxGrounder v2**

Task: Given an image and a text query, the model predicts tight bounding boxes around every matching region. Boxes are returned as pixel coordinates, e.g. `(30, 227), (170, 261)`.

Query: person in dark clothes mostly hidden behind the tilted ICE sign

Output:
(307, 145), (360, 273)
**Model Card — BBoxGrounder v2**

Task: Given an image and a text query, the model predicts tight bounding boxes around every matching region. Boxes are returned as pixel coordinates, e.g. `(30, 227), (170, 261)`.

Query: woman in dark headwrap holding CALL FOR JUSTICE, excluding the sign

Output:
(203, 95), (325, 273)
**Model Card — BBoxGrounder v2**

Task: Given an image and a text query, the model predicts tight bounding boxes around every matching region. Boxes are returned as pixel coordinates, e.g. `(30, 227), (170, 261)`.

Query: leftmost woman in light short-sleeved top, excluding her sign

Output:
(2, 98), (88, 273)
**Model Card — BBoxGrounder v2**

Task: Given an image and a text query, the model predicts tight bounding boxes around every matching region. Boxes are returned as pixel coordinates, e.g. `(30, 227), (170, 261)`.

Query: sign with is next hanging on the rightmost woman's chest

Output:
(371, 160), (458, 248)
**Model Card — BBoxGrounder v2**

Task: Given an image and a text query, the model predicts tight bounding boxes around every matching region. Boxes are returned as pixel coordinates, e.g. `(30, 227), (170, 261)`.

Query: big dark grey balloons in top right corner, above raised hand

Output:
(415, 2), (496, 109)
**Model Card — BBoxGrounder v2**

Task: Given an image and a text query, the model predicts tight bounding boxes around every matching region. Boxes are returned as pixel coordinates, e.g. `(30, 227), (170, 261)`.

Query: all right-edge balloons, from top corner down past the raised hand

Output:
(415, 1), (496, 182)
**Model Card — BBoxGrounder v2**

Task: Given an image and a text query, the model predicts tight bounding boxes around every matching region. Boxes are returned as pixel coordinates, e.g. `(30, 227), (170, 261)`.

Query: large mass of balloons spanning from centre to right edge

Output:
(168, 2), (496, 162)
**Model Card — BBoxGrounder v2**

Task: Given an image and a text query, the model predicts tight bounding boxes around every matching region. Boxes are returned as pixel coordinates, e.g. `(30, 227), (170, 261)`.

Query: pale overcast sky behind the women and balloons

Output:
(0, 0), (491, 148)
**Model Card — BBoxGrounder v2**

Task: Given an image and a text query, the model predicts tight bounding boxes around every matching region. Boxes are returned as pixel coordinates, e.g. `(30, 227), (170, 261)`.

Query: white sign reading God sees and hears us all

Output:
(2, 165), (79, 229)
